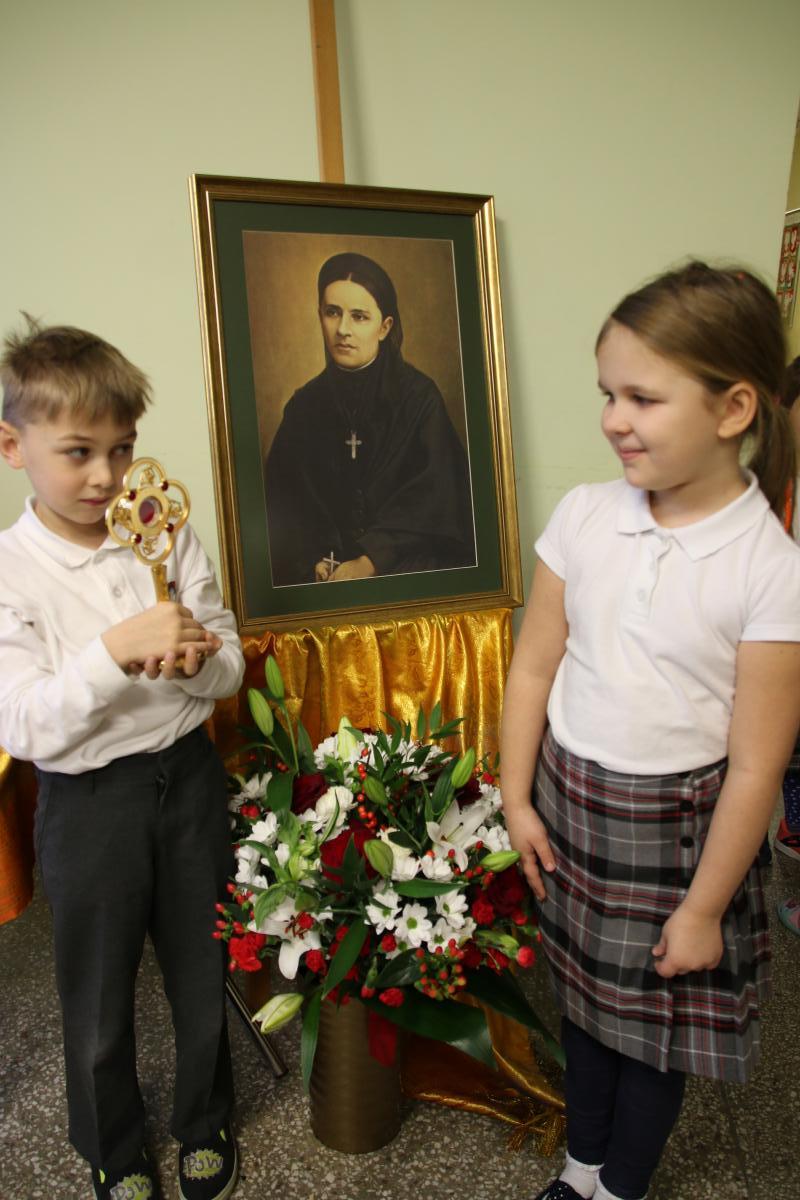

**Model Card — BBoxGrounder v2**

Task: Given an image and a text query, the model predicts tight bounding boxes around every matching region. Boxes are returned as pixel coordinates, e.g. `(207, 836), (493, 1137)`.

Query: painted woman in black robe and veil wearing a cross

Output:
(264, 253), (475, 587)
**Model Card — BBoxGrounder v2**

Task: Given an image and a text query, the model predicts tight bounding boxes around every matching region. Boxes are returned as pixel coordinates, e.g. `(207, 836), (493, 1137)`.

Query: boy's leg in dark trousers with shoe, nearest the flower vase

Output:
(151, 730), (237, 1200)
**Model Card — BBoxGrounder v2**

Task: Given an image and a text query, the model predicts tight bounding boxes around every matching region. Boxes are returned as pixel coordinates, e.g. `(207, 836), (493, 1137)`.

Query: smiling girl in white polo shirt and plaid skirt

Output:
(501, 263), (800, 1200)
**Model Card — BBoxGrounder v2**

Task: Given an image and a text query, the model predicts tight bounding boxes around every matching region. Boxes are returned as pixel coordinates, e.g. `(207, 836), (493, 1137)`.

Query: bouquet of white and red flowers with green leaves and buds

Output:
(215, 658), (561, 1086)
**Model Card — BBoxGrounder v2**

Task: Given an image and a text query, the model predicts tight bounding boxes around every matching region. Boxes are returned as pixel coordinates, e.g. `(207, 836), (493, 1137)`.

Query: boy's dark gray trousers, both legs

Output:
(35, 727), (233, 1170)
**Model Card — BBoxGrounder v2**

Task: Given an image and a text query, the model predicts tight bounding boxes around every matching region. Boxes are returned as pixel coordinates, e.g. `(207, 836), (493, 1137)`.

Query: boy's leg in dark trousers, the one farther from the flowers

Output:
(36, 763), (155, 1195)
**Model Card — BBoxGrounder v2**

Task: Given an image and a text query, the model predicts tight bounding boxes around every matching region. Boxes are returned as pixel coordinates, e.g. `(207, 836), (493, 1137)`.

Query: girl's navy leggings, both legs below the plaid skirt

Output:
(561, 1016), (686, 1200)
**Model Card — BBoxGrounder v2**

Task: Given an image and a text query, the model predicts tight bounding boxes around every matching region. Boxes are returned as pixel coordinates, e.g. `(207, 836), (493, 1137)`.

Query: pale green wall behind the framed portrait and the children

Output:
(0, 0), (800, 609)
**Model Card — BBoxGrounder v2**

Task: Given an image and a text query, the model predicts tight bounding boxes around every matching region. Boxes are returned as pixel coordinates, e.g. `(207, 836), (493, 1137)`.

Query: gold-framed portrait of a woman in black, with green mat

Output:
(191, 175), (522, 634)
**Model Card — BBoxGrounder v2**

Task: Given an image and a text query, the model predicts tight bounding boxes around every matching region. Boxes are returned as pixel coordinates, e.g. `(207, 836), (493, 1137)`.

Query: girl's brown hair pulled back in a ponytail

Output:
(597, 262), (795, 517)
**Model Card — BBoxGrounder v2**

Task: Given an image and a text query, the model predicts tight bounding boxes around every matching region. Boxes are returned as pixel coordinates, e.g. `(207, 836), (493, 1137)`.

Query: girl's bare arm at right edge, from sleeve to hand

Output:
(652, 642), (800, 978)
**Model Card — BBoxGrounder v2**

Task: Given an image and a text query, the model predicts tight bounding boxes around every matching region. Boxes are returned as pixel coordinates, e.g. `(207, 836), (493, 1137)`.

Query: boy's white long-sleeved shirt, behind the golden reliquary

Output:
(0, 499), (243, 774)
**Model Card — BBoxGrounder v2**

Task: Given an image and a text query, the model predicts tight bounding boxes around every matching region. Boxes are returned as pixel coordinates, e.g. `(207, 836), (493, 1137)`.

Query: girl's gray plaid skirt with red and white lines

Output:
(534, 730), (770, 1082)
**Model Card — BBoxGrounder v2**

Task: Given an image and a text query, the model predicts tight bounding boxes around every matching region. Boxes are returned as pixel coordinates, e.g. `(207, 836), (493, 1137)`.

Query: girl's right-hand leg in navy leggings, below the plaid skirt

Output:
(595, 1055), (686, 1200)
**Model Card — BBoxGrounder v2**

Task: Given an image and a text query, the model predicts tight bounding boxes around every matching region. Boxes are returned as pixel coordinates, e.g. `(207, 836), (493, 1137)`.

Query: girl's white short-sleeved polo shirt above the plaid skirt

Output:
(536, 473), (800, 774)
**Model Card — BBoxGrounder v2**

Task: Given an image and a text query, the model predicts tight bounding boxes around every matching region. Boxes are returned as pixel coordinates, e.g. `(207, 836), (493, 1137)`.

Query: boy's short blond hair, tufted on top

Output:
(0, 313), (151, 428)
